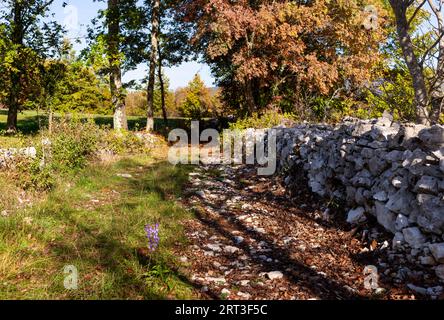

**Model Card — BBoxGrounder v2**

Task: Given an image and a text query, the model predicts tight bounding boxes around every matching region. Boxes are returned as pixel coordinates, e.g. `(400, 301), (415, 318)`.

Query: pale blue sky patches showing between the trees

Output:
(51, 0), (214, 90)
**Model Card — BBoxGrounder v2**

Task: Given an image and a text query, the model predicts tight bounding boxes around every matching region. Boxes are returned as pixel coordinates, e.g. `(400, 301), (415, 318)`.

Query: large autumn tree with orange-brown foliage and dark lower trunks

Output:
(182, 0), (385, 119)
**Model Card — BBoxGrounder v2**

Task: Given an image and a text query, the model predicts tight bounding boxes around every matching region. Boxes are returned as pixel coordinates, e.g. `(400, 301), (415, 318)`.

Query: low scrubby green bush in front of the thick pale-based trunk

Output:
(12, 119), (153, 190)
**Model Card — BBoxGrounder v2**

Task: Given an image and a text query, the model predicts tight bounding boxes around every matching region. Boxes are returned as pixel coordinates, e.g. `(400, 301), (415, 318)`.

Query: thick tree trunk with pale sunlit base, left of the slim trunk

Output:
(108, 0), (128, 130)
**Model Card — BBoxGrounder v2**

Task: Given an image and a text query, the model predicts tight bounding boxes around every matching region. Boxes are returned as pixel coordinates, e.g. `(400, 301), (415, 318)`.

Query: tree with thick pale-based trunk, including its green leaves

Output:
(87, 0), (146, 130)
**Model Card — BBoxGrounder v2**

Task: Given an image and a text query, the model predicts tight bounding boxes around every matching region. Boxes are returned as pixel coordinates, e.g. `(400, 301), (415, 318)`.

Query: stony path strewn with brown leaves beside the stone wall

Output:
(177, 166), (440, 300)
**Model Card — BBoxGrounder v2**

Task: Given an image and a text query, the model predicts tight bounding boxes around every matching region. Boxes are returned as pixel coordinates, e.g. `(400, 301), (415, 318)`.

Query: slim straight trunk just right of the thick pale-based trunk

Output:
(146, 0), (160, 132)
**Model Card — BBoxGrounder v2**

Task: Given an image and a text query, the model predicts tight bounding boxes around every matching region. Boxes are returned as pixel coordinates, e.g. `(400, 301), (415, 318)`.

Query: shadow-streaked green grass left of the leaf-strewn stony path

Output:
(0, 152), (198, 299)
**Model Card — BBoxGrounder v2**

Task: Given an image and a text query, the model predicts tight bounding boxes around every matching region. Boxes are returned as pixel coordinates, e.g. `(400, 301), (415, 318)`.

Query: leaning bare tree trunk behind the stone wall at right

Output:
(390, 0), (430, 125)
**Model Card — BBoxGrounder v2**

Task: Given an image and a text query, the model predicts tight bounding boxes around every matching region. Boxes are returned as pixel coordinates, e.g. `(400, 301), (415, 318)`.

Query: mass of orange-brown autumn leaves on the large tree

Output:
(186, 0), (384, 105)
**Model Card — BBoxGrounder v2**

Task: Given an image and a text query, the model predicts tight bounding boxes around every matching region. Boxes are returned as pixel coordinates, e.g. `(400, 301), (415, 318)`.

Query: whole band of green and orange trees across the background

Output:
(0, 0), (444, 130)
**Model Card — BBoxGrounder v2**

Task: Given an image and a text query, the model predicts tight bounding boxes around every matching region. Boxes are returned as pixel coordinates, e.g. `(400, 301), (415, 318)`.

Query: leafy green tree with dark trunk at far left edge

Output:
(0, 0), (63, 131)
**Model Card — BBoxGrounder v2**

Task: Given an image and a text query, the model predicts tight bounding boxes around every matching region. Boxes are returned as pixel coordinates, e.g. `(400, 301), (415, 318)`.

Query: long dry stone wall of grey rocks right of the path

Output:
(277, 114), (444, 279)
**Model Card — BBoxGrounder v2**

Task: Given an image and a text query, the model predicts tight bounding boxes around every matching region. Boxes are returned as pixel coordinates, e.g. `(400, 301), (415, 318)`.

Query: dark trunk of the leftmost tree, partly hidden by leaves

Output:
(6, 1), (24, 132)
